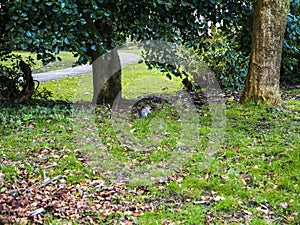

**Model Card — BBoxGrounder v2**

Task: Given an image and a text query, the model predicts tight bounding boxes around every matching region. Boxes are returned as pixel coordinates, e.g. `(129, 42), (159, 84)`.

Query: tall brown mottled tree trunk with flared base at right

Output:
(240, 0), (290, 106)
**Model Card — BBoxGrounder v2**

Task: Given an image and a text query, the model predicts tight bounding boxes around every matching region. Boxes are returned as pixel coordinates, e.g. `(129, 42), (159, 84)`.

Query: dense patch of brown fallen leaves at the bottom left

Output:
(0, 143), (154, 224)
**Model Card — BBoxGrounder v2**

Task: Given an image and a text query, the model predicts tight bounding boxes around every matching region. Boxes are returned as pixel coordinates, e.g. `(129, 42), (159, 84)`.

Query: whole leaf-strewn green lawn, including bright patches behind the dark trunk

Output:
(0, 57), (300, 225)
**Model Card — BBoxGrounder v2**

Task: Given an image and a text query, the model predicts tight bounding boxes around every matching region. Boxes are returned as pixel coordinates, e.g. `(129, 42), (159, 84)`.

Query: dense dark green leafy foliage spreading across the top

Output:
(0, 0), (300, 92)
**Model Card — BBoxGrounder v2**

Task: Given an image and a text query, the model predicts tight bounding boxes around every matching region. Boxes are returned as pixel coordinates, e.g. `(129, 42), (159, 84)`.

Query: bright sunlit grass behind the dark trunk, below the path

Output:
(40, 63), (182, 101)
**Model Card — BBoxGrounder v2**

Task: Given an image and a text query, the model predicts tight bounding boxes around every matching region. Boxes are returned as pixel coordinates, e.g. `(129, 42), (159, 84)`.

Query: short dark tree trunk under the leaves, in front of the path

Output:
(93, 49), (122, 105)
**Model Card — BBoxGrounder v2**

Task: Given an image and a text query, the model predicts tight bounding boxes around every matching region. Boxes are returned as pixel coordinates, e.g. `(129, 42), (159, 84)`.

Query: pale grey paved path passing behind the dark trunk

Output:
(33, 52), (141, 82)
